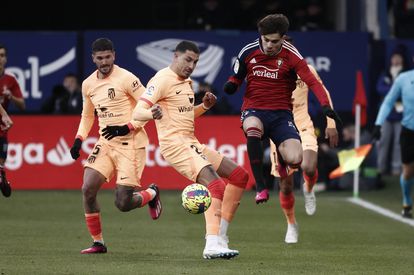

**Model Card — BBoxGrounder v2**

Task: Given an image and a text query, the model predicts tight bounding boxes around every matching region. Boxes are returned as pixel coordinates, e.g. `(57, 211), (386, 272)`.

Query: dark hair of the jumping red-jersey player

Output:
(257, 13), (289, 36)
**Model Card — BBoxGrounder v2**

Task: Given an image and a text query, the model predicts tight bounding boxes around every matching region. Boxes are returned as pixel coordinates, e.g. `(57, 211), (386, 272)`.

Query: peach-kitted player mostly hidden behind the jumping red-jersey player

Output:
(268, 65), (338, 243)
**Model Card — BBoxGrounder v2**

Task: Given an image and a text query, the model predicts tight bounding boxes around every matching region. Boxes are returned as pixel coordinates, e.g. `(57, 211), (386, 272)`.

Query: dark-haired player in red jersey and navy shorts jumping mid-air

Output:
(224, 14), (340, 239)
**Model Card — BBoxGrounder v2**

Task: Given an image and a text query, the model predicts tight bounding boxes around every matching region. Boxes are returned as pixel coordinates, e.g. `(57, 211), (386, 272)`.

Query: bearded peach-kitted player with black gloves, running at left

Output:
(70, 38), (162, 254)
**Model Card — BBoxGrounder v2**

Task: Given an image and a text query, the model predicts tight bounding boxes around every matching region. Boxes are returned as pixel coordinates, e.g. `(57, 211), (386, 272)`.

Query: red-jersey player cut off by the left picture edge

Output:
(0, 44), (25, 197)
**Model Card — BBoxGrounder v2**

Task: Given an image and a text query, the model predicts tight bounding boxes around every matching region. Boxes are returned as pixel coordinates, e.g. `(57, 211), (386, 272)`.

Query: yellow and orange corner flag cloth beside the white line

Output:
(329, 144), (372, 179)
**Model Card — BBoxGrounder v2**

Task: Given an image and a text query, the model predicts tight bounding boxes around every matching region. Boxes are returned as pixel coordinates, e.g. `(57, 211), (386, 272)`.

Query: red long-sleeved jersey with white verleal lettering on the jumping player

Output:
(229, 39), (329, 110)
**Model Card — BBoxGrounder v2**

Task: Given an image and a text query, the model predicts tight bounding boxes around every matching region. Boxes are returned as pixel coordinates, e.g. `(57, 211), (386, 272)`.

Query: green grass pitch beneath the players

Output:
(0, 178), (414, 274)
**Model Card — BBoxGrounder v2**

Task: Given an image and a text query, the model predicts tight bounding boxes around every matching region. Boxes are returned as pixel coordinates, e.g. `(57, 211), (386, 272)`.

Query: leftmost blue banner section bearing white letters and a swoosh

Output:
(0, 32), (77, 112)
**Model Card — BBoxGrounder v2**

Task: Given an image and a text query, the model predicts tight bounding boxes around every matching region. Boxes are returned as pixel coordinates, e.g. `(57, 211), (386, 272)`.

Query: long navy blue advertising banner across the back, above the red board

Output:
(0, 31), (369, 114)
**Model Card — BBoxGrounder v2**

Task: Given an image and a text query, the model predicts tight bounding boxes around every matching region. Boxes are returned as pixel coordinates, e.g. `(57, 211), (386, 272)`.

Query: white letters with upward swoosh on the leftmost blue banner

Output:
(6, 47), (76, 98)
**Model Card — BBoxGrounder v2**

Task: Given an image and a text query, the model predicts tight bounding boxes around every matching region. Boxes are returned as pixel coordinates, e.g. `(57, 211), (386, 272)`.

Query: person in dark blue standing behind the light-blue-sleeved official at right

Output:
(377, 45), (410, 175)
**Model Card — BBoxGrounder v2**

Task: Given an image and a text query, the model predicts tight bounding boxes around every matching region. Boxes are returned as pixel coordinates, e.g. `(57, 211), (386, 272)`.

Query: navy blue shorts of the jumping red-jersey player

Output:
(241, 109), (301, 147)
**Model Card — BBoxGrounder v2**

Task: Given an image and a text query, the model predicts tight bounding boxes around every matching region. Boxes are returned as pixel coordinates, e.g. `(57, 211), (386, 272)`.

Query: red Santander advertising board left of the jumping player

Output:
(6, 116), (253, 190)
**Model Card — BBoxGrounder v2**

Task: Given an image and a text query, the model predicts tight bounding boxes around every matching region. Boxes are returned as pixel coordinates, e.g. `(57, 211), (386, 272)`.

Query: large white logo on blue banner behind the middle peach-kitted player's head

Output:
(136, 38), (224, 83)
